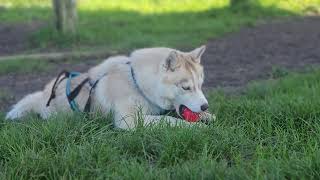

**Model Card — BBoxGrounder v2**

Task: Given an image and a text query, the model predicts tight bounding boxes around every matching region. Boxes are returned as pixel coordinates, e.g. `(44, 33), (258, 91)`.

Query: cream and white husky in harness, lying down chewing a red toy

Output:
(6, 46), (213, 129)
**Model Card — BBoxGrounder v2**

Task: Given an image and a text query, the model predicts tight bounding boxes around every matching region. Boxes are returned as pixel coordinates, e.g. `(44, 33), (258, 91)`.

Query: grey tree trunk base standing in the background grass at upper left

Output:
(52, 0), (77, 34)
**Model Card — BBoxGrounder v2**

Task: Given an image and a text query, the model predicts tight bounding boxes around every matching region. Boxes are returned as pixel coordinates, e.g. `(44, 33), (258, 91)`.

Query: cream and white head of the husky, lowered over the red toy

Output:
(162, 46), (208, 116)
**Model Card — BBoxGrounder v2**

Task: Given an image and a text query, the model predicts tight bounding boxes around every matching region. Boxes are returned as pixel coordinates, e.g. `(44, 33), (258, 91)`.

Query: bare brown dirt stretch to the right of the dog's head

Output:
(204, 17), (320, 87)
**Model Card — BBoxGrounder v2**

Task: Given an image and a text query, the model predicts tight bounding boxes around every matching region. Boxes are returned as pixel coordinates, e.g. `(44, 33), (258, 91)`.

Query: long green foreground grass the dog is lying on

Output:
(0, 70), (320, 179)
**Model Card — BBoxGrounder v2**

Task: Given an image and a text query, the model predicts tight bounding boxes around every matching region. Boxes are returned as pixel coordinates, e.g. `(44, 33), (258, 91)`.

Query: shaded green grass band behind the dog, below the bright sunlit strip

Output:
(0, 3), (296, 51)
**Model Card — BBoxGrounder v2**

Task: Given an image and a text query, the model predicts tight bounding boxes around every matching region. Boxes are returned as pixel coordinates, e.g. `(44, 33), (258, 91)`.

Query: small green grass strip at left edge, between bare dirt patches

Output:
(0, 58), (54, 75)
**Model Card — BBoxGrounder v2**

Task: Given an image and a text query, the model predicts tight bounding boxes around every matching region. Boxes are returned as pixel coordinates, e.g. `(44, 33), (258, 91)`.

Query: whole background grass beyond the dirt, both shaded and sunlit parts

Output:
(0, 0), (320, 50)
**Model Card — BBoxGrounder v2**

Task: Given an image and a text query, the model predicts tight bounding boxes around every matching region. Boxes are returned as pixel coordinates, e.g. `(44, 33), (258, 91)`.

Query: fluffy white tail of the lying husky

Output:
(6, 91), (46, 120)
